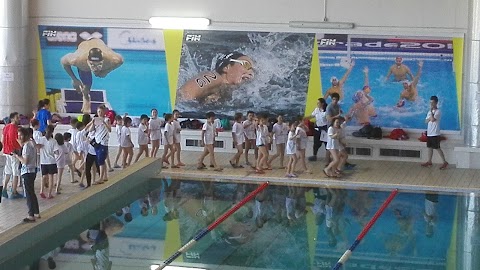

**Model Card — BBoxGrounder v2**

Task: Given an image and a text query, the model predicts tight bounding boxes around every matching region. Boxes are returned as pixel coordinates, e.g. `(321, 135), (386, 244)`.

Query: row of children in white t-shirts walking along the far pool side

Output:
(101, 106), (347, 178)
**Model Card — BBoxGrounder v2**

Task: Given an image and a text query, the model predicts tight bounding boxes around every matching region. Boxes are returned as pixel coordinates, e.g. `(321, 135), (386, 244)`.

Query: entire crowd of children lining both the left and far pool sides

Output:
(2, 100), (354, 223)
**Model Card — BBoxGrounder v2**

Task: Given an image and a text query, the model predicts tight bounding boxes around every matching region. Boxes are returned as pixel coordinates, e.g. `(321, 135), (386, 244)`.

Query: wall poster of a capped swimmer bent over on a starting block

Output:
(38, 26), (172, 116)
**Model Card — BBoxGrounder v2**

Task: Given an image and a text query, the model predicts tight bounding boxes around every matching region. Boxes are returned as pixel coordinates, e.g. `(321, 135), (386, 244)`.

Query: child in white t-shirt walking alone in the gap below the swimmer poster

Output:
(197, 112), (223, 171)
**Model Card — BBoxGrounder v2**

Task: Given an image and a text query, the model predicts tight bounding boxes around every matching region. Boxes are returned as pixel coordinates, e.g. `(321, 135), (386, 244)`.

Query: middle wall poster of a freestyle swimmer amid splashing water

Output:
(175, 31), (314, 118)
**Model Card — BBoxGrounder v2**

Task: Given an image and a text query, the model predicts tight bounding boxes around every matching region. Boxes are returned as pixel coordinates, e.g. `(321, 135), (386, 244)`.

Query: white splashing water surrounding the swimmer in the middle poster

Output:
(176, 32), (314, 117)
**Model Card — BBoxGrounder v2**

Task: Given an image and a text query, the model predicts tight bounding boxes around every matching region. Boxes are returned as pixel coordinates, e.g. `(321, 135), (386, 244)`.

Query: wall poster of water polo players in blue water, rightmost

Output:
(317, 35), (463, 131)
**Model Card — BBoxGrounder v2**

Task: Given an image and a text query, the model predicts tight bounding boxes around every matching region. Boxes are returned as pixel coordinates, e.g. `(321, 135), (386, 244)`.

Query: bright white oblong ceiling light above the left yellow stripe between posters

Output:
(148, 17), (210, 29)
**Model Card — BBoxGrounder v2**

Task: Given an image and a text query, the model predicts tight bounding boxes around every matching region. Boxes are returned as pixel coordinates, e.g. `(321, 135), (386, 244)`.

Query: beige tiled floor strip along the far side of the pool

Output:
(159, 152), (480, 193)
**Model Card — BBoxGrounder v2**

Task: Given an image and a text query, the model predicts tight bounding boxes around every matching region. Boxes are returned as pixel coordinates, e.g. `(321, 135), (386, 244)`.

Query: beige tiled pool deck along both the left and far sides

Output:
(0, 147), (480, 238)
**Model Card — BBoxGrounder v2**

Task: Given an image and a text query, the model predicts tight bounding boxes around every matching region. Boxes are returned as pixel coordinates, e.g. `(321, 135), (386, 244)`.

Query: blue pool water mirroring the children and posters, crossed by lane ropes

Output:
(37, 179), (456, 270)
